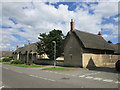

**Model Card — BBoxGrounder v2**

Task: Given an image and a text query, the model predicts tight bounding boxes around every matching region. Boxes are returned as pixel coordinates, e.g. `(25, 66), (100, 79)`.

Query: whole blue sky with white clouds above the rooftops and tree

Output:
(0, 1), (120, 50)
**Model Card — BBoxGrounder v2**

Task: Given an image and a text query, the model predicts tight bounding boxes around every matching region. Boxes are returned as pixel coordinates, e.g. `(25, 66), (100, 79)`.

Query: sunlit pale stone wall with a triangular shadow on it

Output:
(82, 54), (120, 68)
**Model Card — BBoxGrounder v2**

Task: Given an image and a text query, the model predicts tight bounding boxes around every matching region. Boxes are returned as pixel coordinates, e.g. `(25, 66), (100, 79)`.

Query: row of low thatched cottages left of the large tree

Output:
(13, 42), (47, 63)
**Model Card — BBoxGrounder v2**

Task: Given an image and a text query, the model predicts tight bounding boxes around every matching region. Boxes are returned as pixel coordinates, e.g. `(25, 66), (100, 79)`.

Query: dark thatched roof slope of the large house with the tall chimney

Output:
(74, 30), (114, 50)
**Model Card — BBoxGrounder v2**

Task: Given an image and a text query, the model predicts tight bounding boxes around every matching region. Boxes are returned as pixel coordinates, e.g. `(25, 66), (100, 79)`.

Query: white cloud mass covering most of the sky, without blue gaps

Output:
(1, 2), (118, 49)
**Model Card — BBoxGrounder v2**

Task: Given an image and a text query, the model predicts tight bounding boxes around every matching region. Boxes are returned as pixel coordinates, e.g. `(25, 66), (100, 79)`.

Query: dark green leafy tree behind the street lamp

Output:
(37, 29), (64, 60)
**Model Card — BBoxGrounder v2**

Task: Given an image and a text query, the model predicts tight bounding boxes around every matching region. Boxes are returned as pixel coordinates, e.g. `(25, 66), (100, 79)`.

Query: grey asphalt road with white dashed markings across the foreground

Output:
(2, 65), (120, 88)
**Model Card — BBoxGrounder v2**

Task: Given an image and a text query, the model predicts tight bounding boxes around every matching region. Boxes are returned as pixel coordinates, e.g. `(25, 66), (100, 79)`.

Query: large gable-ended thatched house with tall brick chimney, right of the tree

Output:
(64, 20), (118, 67)
